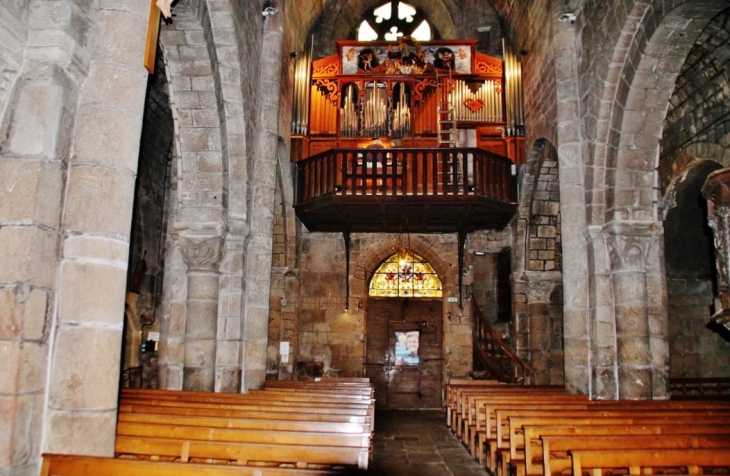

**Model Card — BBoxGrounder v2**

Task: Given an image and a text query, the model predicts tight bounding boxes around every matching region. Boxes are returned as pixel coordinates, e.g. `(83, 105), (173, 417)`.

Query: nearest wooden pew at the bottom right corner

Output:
(570, 448), (730, 476)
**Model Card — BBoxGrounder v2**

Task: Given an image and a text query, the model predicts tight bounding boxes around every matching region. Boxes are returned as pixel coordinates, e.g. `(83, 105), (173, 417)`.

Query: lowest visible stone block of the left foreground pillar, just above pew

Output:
(44, 410), (118, 457)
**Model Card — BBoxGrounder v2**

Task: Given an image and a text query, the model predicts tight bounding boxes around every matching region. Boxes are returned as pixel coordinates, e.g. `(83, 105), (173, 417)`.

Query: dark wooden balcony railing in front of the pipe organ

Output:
(297, 148), (517, 204)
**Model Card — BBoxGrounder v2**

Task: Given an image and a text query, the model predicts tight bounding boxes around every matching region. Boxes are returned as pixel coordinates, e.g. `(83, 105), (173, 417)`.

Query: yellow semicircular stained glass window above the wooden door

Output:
(370, 250), (442, 298)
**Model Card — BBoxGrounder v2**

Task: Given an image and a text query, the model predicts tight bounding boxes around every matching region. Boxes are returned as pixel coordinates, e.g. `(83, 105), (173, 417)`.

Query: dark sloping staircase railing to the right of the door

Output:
(471, 296), (535, 385)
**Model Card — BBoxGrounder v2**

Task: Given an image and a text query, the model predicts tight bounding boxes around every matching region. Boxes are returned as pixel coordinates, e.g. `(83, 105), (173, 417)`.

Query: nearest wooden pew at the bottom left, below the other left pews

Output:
(40, 454), (343, 476)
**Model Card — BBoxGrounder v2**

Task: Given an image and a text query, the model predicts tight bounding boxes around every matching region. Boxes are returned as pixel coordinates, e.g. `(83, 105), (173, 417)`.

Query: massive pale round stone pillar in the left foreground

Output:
(40, 2), (149, 462)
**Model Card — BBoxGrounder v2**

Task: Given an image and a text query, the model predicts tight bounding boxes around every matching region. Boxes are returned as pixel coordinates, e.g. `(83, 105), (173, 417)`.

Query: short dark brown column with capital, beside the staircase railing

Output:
(526, 272), (562, 385)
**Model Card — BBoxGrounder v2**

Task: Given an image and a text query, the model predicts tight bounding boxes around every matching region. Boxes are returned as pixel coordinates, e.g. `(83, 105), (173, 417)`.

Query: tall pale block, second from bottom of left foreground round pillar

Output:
(49, 325), (122, 410)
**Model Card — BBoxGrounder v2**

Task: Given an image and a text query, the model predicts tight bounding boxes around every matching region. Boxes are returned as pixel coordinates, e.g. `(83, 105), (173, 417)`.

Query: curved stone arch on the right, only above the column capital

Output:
(596, 0), (722, 222)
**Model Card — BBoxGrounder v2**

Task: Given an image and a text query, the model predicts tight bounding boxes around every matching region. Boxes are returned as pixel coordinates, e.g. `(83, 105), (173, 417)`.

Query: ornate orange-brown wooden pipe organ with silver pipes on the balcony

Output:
(292, 40), (524, 161)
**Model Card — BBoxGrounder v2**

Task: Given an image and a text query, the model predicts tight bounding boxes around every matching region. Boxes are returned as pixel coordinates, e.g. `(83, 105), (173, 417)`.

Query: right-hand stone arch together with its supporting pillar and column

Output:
(580, 0), (721, 399)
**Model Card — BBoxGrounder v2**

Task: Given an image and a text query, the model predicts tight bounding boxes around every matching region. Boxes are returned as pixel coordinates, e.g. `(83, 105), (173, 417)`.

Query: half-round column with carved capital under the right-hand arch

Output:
(606, 224), (668, 400)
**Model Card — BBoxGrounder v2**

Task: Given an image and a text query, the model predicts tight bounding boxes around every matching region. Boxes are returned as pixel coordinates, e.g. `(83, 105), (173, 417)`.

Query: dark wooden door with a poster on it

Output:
(365, 299), (443, 409)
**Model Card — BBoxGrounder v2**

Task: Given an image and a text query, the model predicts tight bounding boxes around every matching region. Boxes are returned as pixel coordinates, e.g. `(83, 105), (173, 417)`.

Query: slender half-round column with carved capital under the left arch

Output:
(179, 236), (223, 392)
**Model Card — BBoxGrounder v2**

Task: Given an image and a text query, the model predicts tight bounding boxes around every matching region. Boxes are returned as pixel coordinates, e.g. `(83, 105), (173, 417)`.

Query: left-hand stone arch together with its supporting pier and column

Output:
(160, 2), (246, 391)
